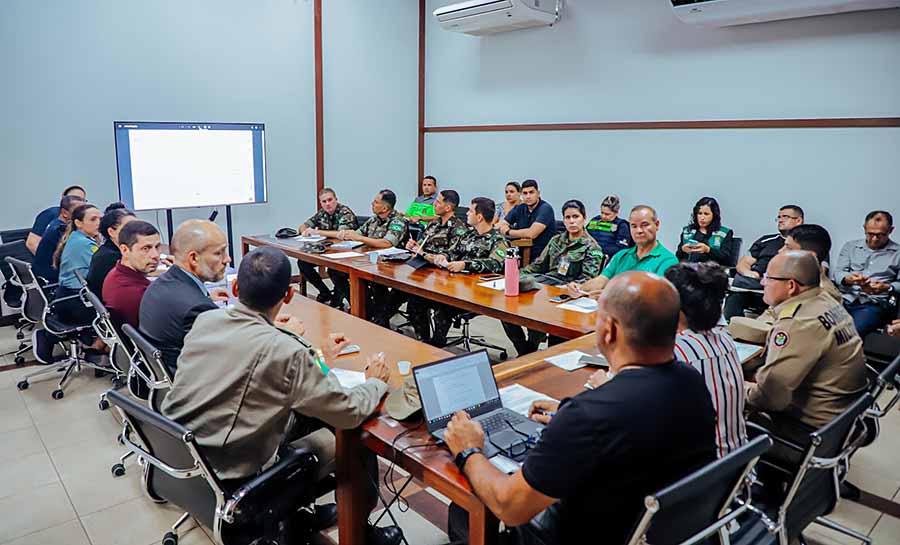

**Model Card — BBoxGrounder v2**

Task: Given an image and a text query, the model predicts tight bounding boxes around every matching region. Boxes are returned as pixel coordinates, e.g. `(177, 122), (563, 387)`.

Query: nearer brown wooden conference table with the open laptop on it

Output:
(282, 297), (595, 545)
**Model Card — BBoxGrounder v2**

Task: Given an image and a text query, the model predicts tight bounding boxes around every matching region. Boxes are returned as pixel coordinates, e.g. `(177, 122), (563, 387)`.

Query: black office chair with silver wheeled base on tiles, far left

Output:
(6, 257), (110, 399)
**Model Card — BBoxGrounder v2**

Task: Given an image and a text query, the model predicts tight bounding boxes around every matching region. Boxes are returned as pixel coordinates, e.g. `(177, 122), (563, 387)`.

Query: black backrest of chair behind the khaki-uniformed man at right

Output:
(779, 392), (873, 540)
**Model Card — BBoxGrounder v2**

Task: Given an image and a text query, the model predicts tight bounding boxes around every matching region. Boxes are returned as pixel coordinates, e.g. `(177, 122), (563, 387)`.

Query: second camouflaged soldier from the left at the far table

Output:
(328, 189), (409, 326)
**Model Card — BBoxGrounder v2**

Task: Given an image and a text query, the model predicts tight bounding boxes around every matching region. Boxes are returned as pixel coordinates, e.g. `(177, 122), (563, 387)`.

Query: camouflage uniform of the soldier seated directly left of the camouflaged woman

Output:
(406, 229), (508, 346)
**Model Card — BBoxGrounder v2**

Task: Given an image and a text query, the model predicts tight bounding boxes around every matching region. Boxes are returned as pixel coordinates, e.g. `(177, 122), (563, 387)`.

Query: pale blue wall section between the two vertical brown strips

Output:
(322, 0), (418, 215)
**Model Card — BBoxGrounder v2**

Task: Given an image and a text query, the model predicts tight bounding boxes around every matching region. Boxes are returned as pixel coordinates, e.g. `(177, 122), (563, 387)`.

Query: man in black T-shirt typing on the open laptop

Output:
(444, 271), (716, 545)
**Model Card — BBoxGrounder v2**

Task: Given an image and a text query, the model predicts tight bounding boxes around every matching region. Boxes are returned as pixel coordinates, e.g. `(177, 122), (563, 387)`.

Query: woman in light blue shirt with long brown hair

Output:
(53, 204), (101, 325)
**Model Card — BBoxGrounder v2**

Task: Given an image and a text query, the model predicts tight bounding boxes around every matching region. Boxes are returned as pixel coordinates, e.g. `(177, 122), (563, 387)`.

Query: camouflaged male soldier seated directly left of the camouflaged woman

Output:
(406, 197), (507, 346)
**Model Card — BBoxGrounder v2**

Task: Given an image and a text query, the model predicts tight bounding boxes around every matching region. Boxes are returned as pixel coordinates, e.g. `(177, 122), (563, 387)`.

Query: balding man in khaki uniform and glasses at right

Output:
(747, 250), (866, 444)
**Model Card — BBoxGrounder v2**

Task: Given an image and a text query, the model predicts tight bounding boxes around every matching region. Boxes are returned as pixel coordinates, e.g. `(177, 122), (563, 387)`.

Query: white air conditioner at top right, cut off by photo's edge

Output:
(671, 0), (900, 27)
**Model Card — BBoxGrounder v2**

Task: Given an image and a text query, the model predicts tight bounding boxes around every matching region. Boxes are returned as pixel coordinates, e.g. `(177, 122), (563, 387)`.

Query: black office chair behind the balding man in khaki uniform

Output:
(738, 392), (874, 545)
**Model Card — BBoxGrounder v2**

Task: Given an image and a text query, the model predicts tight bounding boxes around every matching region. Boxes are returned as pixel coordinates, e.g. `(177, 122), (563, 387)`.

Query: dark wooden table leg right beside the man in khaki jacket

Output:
(335, 428), (370, 544)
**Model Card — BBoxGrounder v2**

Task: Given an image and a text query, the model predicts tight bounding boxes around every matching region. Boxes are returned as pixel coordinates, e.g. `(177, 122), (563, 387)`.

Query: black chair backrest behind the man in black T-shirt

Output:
(628, 435), (772, 545)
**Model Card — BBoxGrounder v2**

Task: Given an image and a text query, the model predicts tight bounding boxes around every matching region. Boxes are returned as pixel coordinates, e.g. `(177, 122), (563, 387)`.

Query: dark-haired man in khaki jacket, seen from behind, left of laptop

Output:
(162, 247), (402, 544)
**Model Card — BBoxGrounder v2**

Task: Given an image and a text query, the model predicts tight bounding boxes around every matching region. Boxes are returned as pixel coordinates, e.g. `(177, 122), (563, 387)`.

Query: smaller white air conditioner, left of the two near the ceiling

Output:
(434, 0), (561, 36)
